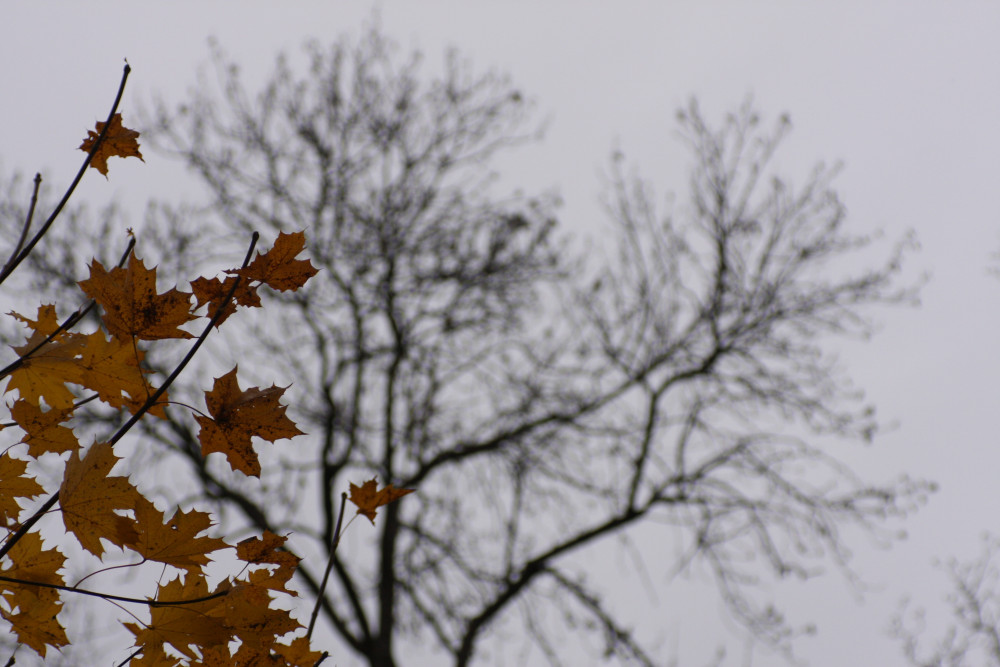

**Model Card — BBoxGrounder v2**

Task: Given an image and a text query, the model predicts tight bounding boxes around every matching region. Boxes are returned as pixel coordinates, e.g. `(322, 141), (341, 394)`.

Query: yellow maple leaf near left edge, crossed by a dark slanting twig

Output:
(7, 305), (85, 409)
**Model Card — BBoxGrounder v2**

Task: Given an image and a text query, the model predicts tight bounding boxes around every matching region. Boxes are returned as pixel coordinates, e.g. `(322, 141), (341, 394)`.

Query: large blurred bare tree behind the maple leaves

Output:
(3, 23), (929, 667)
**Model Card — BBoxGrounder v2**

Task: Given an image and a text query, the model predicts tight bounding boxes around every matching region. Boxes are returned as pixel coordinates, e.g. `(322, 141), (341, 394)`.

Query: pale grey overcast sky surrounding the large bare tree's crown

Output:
(0, 0), (1000, 667)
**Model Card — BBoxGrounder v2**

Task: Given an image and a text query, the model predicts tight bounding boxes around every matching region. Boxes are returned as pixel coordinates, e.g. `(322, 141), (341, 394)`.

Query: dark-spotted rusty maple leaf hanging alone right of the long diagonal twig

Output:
(195, 368), (302, 477)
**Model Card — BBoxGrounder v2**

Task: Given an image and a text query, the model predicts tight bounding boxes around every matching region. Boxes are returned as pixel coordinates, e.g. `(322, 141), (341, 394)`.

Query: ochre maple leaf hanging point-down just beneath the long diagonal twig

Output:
(59, 442), (142, 558)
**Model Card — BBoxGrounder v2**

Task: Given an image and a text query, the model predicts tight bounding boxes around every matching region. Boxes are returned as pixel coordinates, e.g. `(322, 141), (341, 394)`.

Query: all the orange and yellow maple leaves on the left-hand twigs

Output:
(0, 77), (409, 667)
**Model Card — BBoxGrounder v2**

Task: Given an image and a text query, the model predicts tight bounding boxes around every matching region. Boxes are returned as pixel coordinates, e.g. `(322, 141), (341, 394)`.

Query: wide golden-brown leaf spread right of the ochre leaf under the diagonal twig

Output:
(129, 498), (229, 570)
